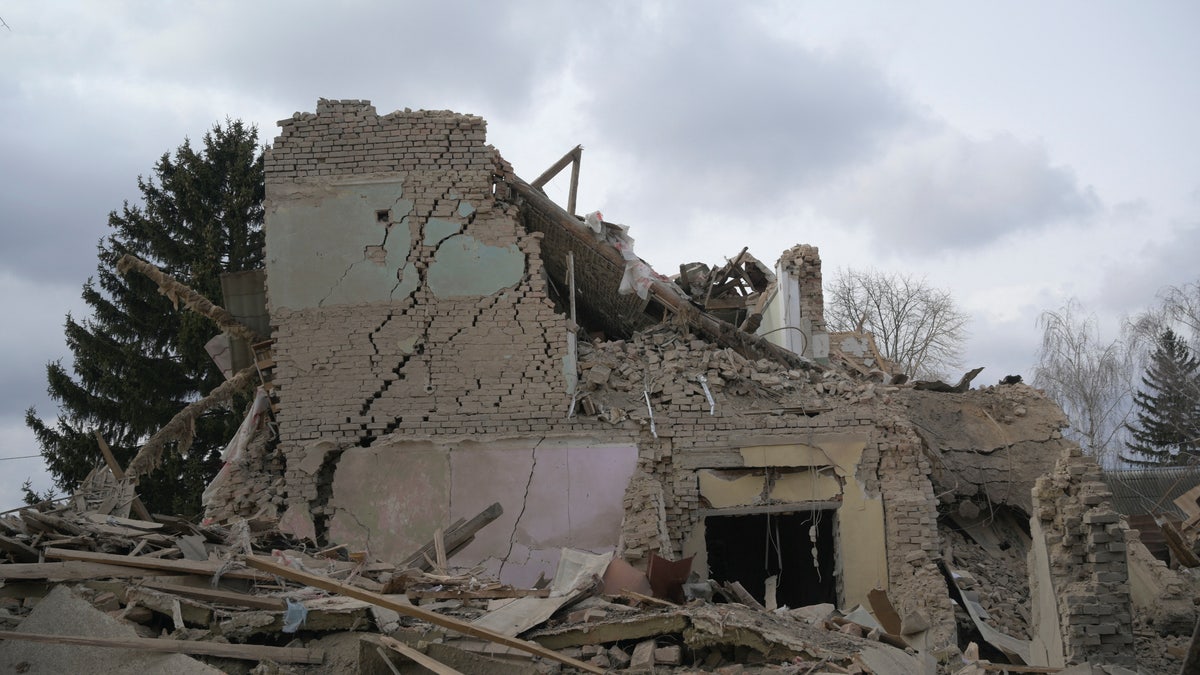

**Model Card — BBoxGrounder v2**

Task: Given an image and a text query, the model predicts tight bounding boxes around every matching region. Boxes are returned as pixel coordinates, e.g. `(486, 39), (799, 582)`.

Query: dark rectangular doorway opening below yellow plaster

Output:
(704, 510), (838, 608)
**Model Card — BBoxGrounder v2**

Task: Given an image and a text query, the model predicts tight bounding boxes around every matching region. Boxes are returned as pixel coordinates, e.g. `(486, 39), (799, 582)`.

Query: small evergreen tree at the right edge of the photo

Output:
(1126, 328), (1200, 465)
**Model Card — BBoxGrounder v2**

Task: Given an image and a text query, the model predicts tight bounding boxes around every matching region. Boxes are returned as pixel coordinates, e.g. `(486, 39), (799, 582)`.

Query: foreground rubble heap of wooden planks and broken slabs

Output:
(0, 477), (924, 673)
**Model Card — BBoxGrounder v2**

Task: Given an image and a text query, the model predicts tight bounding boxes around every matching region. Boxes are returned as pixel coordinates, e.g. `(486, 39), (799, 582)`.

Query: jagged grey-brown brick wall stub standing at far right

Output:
(1033, 446), (1136, 667)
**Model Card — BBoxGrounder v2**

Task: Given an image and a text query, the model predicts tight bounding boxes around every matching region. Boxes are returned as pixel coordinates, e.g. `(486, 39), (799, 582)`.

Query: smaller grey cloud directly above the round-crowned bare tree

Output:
(816, 129), (1100, 253)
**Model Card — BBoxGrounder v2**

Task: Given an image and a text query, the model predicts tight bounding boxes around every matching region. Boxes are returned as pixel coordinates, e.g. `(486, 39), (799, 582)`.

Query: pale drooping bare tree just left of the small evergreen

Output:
(1033, 299), (1145, 464)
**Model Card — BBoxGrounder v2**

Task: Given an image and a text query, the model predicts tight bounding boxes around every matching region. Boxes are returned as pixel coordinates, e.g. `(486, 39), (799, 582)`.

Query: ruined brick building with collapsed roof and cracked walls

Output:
(4, 100), (1193, 671)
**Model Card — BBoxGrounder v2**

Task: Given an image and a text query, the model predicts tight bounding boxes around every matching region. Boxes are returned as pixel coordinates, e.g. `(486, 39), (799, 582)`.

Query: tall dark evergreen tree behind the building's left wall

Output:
(25, 120), (264, 515)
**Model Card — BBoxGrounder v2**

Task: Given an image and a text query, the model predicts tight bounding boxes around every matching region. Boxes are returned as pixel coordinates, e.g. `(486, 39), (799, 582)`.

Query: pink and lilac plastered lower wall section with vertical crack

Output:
(319, 438), (637, 587)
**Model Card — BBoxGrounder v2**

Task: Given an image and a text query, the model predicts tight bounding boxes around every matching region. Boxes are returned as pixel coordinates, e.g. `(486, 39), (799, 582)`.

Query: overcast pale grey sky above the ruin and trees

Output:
(0, 0), (1200, 509)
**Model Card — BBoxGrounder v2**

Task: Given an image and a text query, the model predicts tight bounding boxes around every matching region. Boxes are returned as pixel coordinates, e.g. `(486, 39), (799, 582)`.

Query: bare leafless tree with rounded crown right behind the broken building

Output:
(826, 270), (968, 380)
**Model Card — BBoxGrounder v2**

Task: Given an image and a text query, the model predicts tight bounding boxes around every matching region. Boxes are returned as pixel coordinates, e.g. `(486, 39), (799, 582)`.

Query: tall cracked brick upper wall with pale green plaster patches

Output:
(266, 100), (604, 530)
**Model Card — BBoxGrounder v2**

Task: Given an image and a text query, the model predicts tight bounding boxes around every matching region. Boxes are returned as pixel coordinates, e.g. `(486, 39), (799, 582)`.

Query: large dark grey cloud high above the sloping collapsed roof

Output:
(561, 4), (922, 218)
